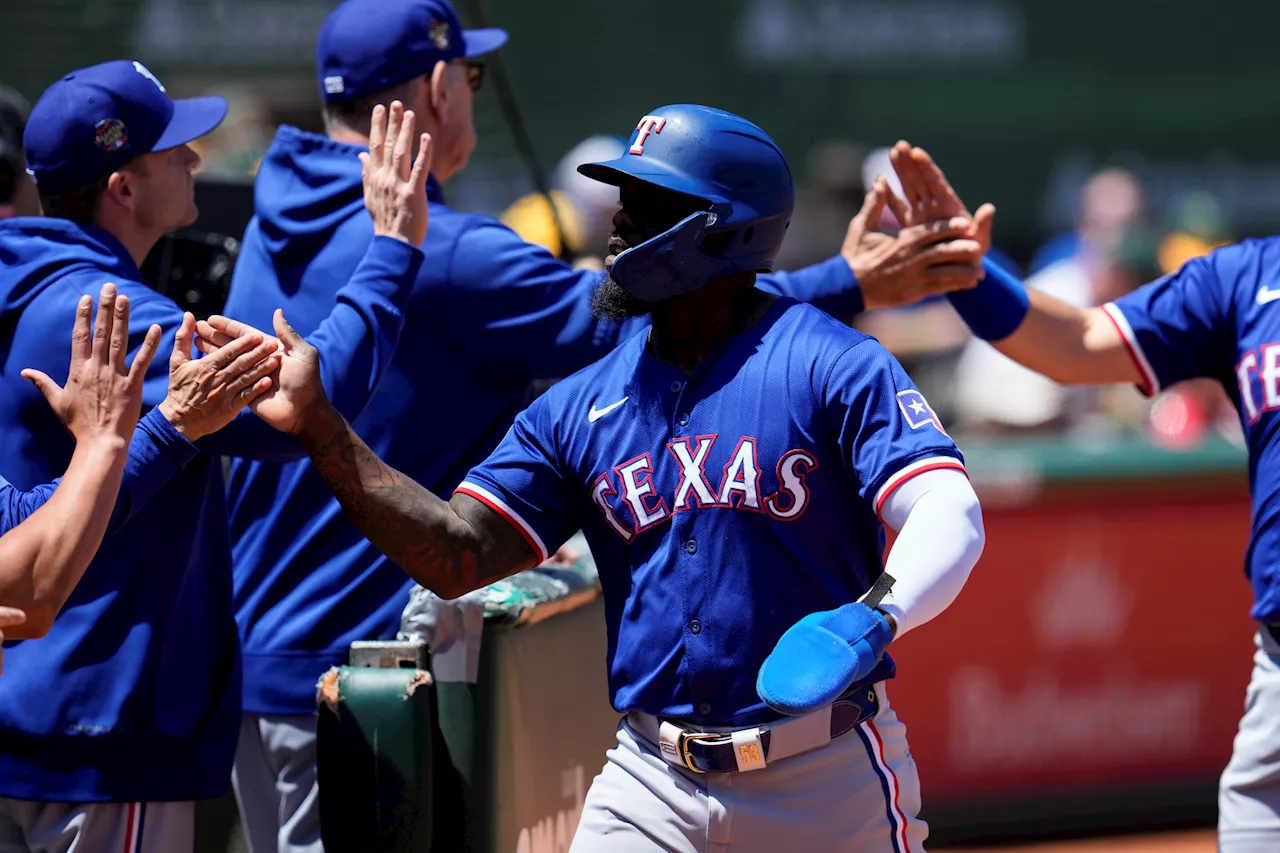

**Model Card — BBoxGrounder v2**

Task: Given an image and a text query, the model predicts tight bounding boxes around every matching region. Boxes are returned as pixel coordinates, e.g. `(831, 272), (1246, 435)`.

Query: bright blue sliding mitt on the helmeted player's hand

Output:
(755, 602), (893, 716)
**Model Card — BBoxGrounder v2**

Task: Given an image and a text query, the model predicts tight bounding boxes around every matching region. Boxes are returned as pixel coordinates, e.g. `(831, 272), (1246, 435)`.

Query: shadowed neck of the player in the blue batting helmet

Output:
(649, 275), (777, 373)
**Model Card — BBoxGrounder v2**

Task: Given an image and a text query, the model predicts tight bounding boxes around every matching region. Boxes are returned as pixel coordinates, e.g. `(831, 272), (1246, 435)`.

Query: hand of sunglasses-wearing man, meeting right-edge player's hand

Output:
(840, 178), (986, 309)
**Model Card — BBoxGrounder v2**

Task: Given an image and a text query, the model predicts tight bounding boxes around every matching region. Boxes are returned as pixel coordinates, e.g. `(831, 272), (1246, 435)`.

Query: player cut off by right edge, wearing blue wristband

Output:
(892, 142), (1280, 853)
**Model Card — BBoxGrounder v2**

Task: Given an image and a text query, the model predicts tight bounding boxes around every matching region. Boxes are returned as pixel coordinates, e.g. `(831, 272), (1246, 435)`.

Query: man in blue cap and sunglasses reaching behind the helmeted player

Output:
(209, 0), (980, 853)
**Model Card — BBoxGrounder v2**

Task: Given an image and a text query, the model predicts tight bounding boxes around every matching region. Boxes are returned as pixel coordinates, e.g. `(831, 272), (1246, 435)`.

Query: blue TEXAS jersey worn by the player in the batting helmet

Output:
(457, 297), (963, 725)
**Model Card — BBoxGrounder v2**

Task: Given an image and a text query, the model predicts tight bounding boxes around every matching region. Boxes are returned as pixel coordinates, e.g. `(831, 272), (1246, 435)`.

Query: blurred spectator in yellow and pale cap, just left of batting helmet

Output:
(502, 136), (622, 262)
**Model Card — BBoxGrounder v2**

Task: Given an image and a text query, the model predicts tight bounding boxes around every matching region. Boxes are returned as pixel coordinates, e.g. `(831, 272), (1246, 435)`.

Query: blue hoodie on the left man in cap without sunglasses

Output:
(0, 216), (422, 802)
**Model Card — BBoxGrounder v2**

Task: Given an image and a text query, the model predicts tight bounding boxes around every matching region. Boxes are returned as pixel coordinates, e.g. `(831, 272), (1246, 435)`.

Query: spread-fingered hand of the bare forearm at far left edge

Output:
(22, 283), (160, 447)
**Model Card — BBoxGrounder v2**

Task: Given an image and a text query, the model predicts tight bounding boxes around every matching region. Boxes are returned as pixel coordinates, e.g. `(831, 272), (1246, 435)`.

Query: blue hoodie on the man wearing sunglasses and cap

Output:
(225, 127), (861, 715)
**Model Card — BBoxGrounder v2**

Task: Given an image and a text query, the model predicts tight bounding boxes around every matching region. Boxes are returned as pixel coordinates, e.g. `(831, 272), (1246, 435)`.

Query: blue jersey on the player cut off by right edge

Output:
(1103, 237), (1280, 624)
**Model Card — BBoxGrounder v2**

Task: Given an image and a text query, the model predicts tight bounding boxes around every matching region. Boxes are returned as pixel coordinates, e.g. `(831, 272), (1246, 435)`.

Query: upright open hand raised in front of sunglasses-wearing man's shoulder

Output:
(360, 101), (431, 246)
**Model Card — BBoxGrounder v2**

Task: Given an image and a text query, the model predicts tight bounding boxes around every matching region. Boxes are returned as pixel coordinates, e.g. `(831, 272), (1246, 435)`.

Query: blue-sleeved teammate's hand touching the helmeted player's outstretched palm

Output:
(160, 311), (280, 442)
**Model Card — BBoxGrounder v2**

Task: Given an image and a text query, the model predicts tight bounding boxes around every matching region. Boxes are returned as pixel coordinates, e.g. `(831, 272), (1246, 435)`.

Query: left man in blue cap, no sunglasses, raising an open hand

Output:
(0, 60), (430, 853)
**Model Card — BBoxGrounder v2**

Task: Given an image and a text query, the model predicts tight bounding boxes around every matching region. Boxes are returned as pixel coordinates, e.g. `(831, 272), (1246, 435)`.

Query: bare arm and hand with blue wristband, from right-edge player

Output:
(888, 142), (1143, 386)
